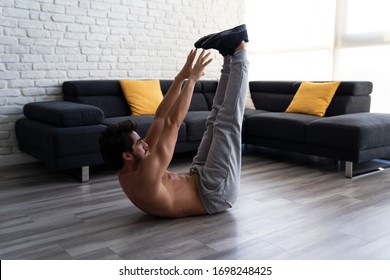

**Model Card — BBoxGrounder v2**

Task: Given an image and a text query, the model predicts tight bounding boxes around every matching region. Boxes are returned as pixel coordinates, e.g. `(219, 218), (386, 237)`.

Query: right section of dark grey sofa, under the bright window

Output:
(247, 81), (390, 178)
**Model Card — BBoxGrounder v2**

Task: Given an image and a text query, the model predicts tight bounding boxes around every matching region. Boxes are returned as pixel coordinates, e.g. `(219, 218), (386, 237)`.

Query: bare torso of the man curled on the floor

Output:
(118, 171), (207, 217)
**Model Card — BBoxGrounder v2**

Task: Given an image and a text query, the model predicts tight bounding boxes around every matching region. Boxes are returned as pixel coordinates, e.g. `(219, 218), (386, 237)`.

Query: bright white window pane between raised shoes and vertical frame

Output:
(246, 0), (335, 80)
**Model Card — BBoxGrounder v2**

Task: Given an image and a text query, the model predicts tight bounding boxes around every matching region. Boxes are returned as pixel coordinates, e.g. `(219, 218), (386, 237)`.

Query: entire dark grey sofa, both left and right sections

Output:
(15, 80), (390, 181)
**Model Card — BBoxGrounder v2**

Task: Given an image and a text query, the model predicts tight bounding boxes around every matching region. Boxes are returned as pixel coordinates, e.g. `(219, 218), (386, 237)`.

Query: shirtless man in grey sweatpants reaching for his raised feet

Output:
(99, 25), (248, 217)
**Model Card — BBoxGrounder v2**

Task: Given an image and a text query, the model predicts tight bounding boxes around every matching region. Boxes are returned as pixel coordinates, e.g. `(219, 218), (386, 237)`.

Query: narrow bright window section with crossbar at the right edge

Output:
(333, 0), (390, 113)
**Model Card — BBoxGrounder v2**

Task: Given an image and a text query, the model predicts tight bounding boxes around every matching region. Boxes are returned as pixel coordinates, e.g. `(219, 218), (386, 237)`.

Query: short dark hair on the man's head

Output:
(99, 120), (137, 171)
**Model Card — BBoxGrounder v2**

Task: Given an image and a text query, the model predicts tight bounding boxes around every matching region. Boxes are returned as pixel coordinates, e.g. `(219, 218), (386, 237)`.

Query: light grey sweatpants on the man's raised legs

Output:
(191, 49), (249, 214)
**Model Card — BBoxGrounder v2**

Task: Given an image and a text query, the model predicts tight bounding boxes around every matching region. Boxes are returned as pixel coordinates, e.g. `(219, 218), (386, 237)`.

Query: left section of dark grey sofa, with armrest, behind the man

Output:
(15, 80), (218, 181)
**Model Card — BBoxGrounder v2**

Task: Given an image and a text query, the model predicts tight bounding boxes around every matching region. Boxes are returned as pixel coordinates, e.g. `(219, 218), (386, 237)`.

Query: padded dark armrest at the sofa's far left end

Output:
(23, 101), (104, 127)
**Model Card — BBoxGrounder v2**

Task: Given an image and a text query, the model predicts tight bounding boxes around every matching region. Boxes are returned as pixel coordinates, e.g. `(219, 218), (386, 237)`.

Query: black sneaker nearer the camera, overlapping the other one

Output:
(202, 24), (249, 56)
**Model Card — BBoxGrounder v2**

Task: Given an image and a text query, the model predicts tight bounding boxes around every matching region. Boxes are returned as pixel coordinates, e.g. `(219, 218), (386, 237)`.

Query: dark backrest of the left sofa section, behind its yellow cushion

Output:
(62, 80), (218, 118)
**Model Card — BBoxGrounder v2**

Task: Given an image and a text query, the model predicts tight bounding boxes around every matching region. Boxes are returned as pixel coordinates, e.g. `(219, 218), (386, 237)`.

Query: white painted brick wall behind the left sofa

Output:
(0, 0), (244, 166)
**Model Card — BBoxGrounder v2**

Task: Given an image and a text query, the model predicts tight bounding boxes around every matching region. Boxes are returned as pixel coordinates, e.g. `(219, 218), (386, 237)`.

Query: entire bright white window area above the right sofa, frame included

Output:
(246, 0), (390, 113)
